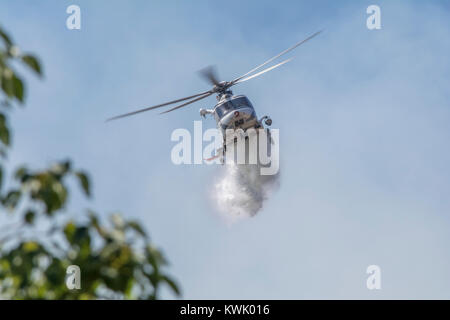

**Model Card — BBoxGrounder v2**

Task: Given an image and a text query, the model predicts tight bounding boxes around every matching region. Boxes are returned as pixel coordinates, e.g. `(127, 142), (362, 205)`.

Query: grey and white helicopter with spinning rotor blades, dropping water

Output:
(106, 30), (322, 160)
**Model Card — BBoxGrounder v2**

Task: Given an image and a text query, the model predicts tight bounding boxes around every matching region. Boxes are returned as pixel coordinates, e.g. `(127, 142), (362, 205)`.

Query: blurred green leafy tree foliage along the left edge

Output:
(0, 28), (179, 299)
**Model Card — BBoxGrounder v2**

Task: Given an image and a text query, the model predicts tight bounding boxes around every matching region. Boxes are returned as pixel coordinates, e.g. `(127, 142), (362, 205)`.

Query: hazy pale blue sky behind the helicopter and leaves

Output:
(0, 0), (450, 299)
